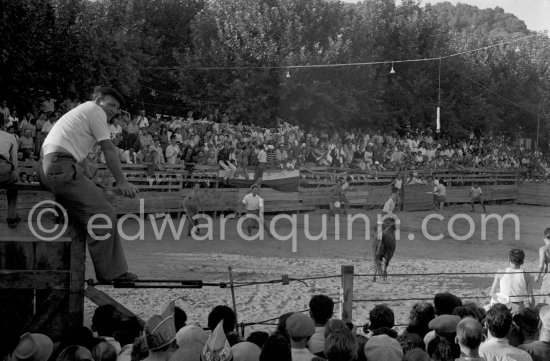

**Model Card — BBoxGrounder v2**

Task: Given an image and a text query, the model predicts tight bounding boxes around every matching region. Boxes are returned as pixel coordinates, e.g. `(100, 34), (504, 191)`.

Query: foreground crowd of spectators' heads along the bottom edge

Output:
(4, 293), (550, 361)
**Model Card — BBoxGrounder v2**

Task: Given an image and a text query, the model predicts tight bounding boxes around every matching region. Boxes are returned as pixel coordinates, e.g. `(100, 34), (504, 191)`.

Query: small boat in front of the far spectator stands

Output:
(222, 169), (300, 192)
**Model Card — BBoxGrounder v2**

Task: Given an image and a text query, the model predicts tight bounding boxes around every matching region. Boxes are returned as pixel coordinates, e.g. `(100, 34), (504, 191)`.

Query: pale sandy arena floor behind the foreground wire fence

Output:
(2, 204), (550, 332)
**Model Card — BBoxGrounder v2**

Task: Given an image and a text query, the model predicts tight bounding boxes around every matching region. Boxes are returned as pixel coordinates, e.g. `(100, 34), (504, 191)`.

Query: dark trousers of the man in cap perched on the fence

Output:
(38, 154), (128, 282)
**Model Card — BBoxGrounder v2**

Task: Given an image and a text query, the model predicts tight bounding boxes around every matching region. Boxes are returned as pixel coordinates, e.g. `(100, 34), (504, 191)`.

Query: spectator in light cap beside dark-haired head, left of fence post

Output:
(286, 313), (315, 361)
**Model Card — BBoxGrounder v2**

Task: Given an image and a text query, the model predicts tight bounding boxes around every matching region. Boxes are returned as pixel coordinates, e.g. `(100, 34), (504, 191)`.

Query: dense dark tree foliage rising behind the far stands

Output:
(0, 0), (550, 143)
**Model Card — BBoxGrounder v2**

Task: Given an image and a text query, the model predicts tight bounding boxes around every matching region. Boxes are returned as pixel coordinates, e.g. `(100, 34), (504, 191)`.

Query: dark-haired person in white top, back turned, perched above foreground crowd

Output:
(490, 249), (535, 313)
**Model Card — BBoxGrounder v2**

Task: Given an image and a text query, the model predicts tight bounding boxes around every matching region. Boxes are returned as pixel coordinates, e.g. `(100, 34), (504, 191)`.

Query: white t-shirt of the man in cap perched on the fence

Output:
(42, 101), (111, 162)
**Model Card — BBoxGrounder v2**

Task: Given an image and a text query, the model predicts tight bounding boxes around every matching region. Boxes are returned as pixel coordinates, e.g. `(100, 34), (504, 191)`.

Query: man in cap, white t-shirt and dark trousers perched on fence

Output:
(38, 86), (138, 283)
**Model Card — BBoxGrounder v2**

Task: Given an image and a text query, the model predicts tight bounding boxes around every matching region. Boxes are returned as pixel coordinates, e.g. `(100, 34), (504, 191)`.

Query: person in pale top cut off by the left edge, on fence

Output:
(0, 114), (21, 228)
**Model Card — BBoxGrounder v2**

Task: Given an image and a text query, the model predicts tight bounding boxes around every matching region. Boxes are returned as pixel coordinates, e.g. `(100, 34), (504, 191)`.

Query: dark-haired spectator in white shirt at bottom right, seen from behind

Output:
(479, 304), (532, 361)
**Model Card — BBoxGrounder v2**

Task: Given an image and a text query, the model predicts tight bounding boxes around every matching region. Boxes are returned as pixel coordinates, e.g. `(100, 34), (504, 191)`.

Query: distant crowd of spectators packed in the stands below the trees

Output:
(0, 99), (550, 179)
